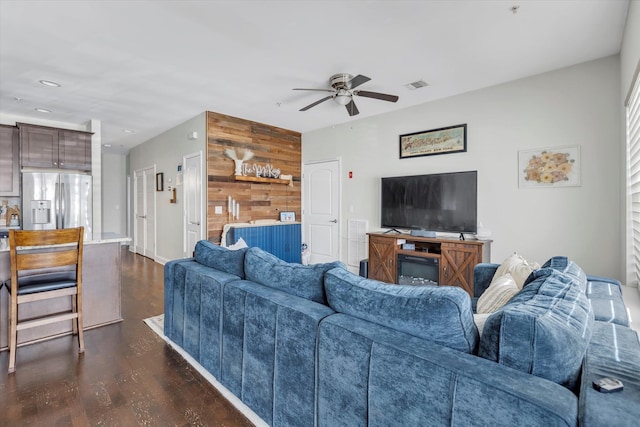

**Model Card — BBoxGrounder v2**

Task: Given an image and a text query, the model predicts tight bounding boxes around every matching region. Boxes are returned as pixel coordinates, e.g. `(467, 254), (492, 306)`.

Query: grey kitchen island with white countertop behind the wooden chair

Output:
(0, 237), (131, 351)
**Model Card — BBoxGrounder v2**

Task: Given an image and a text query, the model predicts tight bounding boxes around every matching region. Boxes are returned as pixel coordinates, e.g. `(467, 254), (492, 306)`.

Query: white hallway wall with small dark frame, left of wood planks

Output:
(128, 113), (207, 263)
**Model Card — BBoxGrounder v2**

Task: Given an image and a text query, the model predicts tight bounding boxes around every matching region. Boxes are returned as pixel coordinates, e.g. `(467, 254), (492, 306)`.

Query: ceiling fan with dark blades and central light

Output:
(293, 73), (398, 116)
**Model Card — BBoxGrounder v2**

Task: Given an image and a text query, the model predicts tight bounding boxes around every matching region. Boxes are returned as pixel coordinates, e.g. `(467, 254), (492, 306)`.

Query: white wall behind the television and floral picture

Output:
(302, 56), (623, 279)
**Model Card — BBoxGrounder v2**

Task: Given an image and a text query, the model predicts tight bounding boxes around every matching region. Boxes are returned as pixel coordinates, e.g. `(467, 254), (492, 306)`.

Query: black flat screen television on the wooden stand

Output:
(381, 171), (478, 233)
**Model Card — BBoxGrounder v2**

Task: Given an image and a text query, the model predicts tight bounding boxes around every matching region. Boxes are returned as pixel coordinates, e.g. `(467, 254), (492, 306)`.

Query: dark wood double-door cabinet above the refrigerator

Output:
(18, 123), (92, 171)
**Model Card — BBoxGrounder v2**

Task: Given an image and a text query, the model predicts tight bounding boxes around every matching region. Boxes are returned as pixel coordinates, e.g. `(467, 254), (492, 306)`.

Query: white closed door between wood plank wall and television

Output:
(302, 160), (341, 264)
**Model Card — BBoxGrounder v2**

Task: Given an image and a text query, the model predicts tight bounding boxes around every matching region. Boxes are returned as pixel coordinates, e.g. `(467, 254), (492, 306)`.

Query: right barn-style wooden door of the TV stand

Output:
(440, 243), (482, 296)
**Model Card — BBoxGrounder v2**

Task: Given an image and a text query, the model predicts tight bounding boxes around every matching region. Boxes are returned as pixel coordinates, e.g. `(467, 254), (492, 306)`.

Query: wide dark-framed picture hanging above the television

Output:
(400, 123), (467, 159)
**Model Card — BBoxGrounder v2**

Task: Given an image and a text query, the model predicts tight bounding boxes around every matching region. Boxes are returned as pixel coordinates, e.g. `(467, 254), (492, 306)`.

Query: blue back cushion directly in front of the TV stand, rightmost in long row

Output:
(324, 269), (478, 353)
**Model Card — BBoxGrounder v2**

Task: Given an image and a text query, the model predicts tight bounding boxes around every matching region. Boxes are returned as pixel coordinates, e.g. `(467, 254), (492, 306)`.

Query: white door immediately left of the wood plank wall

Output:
(182, 153), (205, 258)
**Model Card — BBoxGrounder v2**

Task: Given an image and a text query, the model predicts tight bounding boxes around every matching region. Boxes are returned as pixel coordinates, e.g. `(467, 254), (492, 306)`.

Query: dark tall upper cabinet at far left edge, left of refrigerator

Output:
(0, 125), (20, 196)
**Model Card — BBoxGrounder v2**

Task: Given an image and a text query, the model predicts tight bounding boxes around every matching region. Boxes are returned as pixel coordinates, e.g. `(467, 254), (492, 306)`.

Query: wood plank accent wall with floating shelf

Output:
(207, 112), (302, 243)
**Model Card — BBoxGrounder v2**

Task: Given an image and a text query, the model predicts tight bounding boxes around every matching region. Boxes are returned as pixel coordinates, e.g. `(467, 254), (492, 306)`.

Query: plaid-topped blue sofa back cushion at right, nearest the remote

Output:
(478, 268), (594, 390)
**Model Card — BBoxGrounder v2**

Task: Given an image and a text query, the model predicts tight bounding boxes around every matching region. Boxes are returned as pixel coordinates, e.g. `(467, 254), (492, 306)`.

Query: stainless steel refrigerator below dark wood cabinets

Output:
(22, 172), (93, 241)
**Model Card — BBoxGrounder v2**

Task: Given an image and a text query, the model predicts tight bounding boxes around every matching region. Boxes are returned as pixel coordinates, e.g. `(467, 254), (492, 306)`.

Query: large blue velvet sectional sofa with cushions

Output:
(164, 241), (640, 426)
